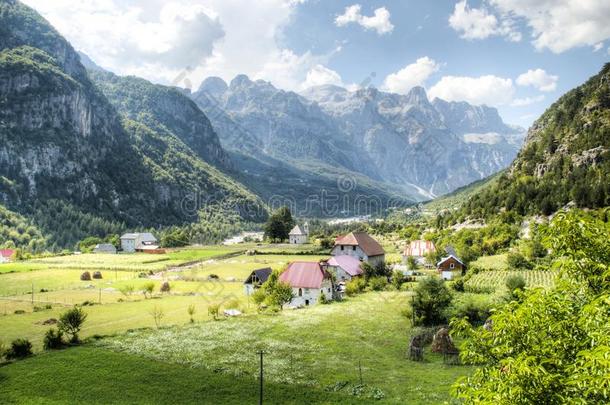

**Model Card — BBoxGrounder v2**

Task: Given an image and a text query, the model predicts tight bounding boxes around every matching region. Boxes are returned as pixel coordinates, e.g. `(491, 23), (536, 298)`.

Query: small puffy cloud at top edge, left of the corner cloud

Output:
(449, 0), (521, 42)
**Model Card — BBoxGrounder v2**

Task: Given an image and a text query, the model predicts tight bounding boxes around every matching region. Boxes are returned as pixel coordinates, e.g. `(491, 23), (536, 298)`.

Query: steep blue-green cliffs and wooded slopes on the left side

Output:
(0, 1), (265, 246)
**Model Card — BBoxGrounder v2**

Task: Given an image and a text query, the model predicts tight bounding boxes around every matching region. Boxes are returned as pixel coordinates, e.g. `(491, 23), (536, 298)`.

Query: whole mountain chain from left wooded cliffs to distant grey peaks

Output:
(0, 0), (521, 248)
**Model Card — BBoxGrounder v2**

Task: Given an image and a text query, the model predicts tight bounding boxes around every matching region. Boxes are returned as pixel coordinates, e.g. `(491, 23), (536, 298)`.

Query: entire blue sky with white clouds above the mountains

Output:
(23, 0), (610, 126)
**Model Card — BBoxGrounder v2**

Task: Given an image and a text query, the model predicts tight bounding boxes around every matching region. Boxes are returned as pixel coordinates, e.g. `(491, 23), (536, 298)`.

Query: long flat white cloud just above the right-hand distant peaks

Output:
(428, 75), (515, 106)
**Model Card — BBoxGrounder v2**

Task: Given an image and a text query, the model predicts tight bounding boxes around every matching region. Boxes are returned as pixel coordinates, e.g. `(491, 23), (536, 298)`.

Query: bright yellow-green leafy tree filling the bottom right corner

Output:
(452, 212), (610, 404)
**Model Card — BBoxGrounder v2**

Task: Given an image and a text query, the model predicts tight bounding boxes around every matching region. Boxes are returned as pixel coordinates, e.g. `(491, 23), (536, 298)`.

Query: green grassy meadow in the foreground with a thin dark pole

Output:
(0, 292), (471, 404)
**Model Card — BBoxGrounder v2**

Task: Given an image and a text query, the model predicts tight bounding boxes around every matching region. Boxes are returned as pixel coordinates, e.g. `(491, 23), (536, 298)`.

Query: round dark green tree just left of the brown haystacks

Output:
(413, 277), (451, 326)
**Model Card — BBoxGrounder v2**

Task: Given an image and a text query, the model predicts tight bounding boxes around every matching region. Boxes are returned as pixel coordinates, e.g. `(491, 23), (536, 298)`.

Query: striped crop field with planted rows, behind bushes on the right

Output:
(465, 270), (557, 291)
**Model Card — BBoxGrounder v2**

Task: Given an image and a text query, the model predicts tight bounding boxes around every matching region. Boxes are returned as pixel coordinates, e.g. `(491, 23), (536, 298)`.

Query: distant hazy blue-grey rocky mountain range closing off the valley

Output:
(192, 75), (524, 201)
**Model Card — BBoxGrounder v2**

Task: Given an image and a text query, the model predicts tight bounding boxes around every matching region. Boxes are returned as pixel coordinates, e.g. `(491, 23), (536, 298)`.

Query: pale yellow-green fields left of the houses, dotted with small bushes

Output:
(0, 245), (325, 350)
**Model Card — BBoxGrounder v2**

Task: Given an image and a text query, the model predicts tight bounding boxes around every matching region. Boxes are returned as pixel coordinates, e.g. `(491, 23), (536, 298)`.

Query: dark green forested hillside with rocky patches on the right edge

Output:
(446, 64), (610, 220)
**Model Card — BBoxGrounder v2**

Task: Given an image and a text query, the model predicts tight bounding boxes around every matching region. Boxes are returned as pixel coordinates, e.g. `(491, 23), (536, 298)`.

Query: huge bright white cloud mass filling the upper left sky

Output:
(24, 0), (318, 89)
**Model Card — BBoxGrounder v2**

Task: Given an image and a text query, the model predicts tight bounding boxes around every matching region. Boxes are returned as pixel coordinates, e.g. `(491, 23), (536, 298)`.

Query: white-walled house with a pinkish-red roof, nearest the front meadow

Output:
(279, 262), (333, 307)
